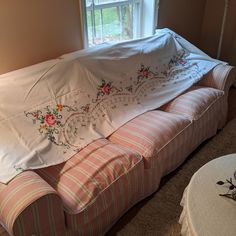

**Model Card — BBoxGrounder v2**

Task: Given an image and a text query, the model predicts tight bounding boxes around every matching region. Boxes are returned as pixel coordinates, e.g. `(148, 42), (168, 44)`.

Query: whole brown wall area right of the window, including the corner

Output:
(158, 0), (236, 65)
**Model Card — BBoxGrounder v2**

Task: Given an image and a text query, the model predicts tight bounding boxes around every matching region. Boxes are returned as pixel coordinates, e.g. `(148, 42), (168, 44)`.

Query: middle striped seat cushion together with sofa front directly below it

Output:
(109, 110), (193, 195)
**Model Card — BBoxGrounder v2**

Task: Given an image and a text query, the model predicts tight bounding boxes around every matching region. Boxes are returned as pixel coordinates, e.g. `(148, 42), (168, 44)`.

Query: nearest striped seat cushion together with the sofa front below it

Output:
(37, 139), (144, 235)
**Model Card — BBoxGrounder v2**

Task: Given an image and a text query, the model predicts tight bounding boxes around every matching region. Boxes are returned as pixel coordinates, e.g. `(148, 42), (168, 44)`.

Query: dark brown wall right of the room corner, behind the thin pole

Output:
(201, 0), (236, 65)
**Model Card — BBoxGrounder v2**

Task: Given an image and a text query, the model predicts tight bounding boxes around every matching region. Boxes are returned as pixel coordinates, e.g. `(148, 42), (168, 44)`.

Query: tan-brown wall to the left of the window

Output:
(0, 0), (82, 74)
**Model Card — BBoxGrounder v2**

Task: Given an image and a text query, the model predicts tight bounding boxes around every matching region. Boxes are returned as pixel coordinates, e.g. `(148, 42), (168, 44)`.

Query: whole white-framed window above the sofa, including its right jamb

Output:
(83, 0), (155, 46)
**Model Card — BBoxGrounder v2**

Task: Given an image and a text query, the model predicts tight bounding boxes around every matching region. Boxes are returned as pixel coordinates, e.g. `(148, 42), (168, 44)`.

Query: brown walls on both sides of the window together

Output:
(0, 0), (236, 74)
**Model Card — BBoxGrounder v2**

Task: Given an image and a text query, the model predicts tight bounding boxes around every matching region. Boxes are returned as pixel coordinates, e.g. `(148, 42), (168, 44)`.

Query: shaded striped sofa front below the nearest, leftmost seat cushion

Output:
(65, 150), (144, 233)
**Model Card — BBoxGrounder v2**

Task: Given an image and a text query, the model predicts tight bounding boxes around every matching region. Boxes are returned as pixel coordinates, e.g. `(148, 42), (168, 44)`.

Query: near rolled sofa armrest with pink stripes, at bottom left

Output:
(0, 171), (65, 236)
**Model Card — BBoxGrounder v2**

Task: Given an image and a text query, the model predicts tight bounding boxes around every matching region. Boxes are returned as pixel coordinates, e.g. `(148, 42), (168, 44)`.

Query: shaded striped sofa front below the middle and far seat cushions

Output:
(140, 92), (227, 197)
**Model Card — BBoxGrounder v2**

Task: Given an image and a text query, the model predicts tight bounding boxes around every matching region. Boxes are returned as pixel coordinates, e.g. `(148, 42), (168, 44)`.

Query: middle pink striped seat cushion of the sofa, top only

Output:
(109, 110), (191, 165)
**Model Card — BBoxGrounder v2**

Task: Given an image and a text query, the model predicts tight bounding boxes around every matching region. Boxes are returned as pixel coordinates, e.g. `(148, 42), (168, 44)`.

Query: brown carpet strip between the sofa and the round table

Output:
(107, 119), (236, 236)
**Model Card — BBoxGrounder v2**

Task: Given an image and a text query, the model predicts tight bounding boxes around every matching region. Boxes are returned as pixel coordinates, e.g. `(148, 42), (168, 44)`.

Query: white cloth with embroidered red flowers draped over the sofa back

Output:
(0, 29), (224, 183)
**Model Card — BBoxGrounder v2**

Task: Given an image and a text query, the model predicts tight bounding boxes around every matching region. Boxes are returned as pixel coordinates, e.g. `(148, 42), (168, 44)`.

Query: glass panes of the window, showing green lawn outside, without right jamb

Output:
(86, 0), (139, 46)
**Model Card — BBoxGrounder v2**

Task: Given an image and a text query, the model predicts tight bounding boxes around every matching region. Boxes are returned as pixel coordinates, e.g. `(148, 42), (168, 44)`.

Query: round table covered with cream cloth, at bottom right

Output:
(179, 154), (236, 236)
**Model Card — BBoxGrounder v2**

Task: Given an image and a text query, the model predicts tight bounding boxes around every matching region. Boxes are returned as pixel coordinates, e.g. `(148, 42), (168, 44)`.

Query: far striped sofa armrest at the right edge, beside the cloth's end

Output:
(198, 65), (236, 93)
